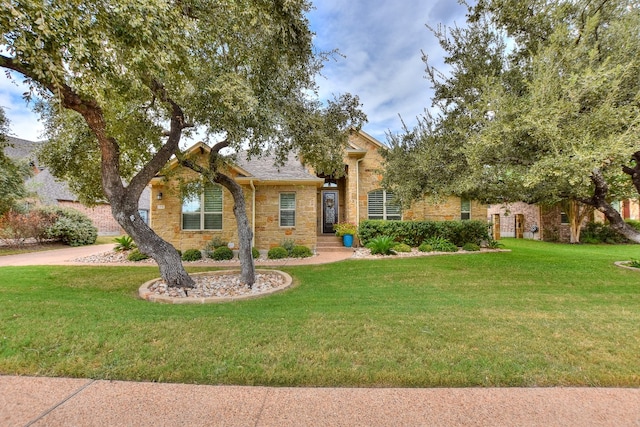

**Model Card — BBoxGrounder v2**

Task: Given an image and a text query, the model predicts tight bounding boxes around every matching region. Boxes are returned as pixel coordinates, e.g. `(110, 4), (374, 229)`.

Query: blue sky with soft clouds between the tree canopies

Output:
(0, 0), (466, 143)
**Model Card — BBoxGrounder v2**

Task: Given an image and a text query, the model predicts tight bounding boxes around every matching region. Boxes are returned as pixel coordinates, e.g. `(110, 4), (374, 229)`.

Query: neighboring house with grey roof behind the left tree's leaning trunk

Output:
(5, 137), (150, 235)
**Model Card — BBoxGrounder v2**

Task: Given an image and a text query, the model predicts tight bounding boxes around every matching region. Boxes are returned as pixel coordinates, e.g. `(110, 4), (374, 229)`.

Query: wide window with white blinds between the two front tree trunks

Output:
(182, 184), (222, 230)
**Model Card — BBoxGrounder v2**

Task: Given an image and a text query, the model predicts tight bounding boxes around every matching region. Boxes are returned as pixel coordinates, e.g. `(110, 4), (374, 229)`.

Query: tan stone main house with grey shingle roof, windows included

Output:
(150, 131), (487, 250)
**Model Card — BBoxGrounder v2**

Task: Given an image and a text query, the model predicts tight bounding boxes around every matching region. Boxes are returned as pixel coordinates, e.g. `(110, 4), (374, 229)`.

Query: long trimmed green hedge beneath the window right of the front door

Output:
(358, 220), (489, 247)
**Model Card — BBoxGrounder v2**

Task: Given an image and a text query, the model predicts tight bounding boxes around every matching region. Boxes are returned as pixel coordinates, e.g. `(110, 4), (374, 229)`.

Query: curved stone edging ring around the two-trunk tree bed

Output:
(138, 269), (293, 304)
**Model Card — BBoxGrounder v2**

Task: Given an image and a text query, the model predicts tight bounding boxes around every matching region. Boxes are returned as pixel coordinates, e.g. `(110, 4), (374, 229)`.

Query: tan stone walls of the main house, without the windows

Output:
(150, 132), (487, 251)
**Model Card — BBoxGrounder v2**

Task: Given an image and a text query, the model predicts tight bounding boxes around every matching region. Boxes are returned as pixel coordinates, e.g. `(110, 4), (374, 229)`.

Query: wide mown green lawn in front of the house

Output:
(0, 240), (640, 387)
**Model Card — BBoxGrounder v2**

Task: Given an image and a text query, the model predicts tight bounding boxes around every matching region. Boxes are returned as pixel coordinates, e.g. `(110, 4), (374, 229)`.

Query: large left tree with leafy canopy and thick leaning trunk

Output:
(0, 0), (364, 285)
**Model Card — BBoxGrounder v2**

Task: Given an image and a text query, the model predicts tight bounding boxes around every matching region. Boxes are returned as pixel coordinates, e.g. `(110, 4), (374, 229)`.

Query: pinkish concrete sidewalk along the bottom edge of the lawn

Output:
(0, 376), (640, 427)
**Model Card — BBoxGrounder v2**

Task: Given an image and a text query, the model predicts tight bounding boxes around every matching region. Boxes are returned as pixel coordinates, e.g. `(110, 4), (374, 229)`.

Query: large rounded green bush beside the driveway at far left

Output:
(41, 206), (98, 246)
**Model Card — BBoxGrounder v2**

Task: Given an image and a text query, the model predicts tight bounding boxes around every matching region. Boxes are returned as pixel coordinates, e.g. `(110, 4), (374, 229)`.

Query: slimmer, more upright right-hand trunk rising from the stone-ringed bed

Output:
(214, 173), (256, 287)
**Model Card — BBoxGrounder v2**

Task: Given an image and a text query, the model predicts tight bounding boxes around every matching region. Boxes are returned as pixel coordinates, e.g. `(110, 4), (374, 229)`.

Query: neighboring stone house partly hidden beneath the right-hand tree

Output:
(488, 199), (640, 242)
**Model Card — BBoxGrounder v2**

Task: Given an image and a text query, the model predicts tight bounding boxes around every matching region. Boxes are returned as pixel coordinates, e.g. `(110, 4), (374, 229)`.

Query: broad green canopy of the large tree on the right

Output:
(387, 0), (640, 241)
